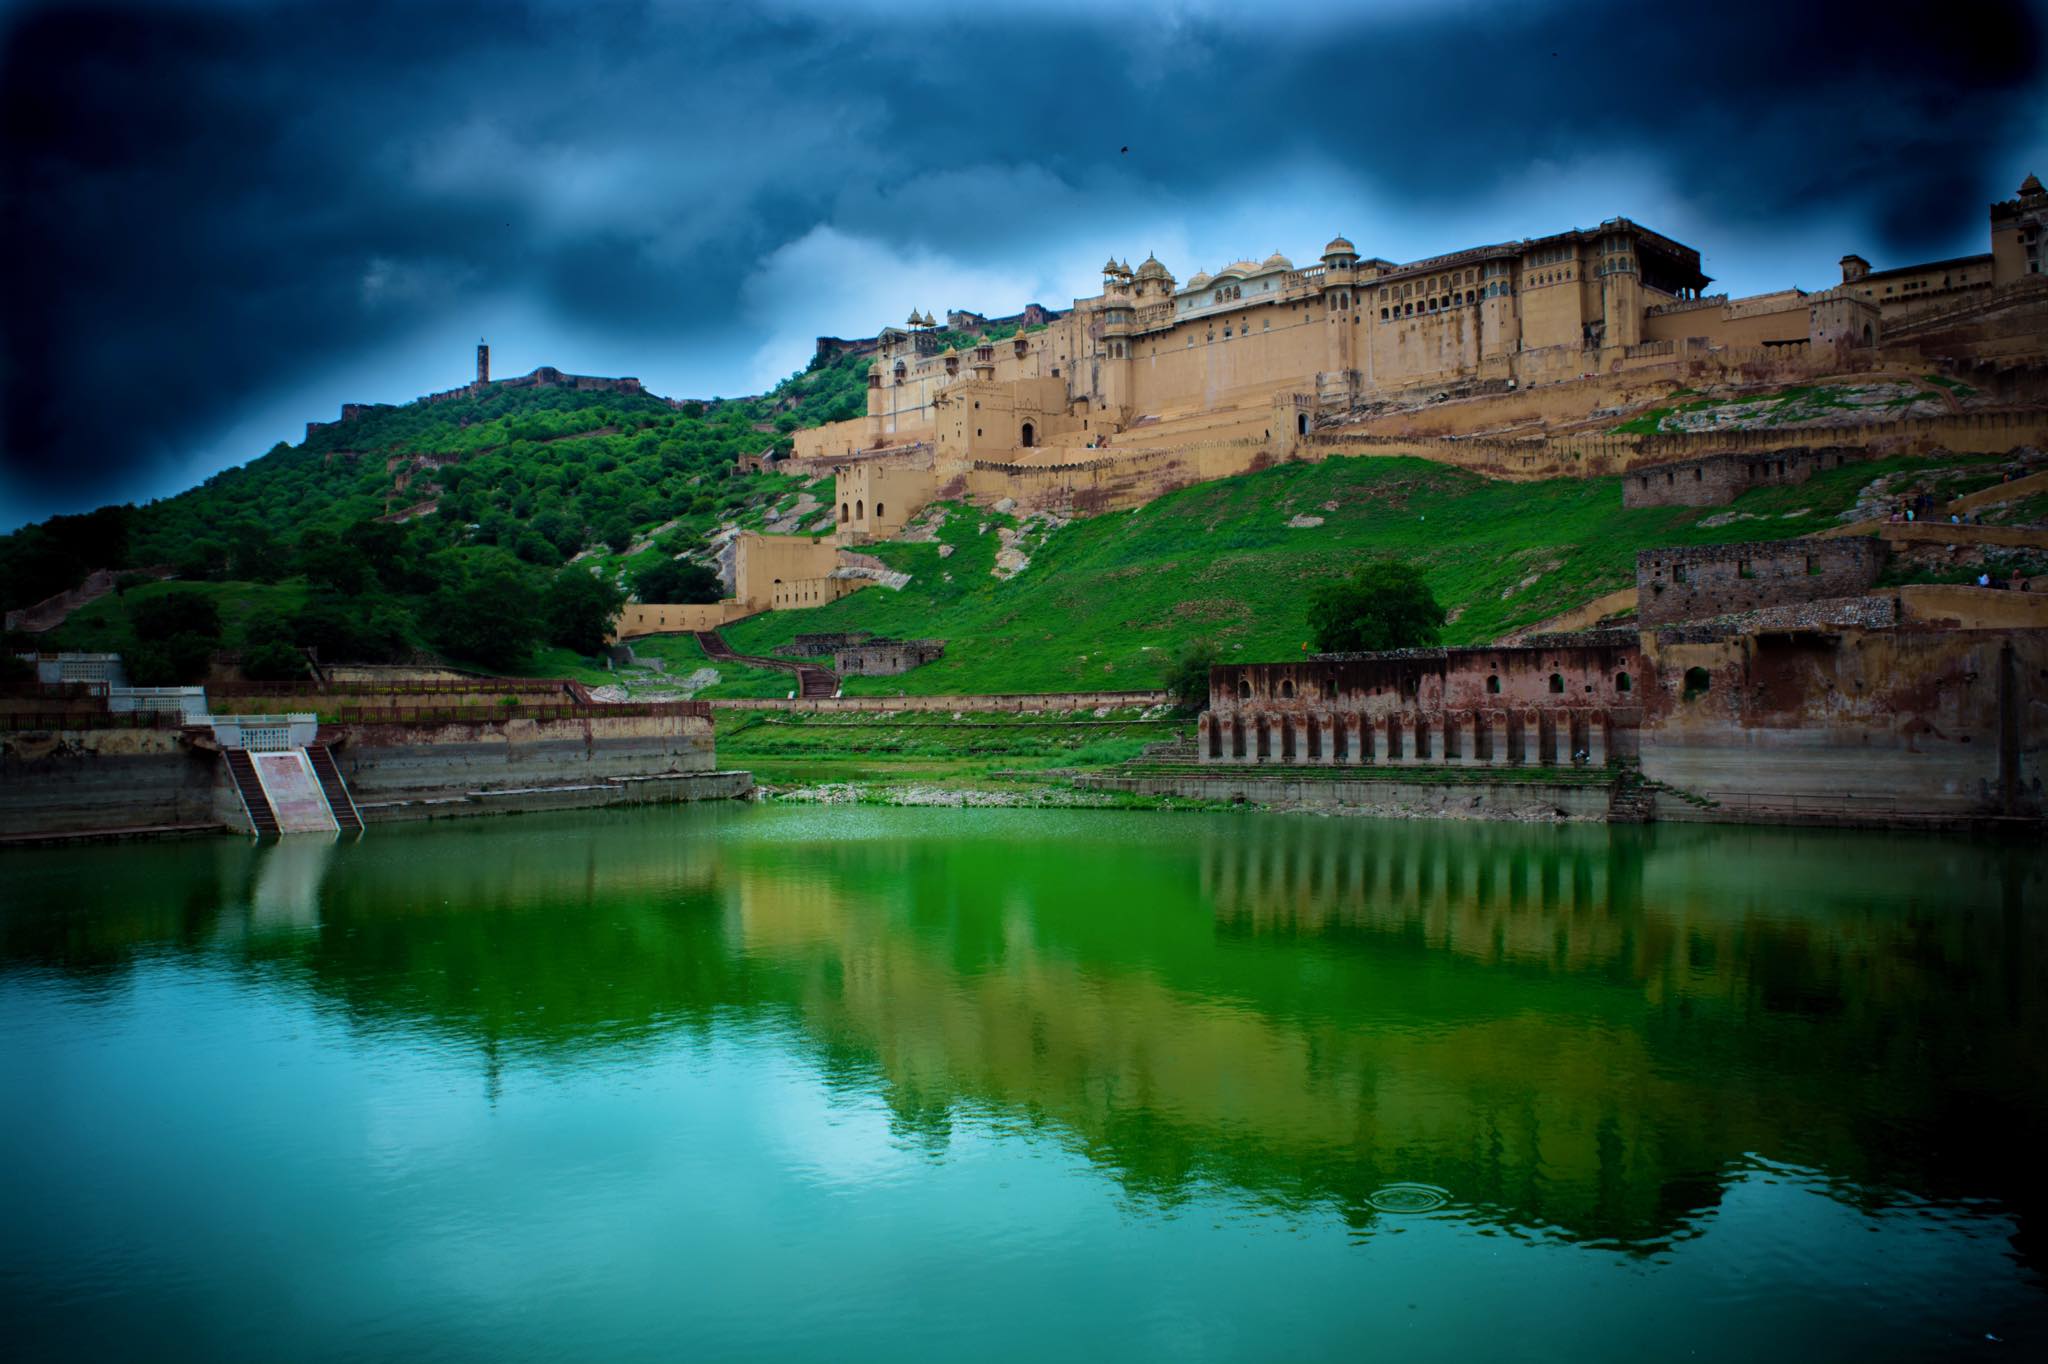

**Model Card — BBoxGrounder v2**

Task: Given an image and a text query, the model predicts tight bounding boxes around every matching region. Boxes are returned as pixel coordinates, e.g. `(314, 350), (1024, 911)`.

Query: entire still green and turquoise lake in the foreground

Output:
(0, 807), (2048, 1360)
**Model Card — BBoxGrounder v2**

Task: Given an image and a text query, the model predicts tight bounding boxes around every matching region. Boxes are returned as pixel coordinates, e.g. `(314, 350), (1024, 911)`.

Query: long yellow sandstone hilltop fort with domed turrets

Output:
(618, 174), (2048, 637)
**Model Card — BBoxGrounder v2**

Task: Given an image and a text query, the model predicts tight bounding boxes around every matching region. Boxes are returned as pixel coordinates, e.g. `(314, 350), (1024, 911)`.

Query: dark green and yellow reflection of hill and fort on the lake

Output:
(0, 817), (2048, 1247)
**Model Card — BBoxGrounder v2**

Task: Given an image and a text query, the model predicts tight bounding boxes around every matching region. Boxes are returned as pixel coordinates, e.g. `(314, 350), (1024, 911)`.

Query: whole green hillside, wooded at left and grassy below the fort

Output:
(0, 333), (1995, 696)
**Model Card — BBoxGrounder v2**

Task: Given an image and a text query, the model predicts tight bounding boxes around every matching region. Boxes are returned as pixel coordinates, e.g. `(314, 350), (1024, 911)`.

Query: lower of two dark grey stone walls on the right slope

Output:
(1636, 537), (1884, 625)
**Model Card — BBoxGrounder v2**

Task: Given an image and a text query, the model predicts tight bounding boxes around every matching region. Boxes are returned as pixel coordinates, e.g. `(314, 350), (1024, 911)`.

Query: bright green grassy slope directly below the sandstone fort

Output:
(725, 457), (1991, 694)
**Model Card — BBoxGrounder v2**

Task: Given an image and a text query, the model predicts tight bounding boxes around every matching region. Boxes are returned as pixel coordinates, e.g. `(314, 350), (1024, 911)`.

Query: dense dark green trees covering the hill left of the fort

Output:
(0, 346), (868, 667)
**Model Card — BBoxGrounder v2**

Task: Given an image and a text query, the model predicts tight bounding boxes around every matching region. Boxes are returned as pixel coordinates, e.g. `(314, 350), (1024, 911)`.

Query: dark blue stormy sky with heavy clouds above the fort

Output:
(0, 0), (2048, 528)
